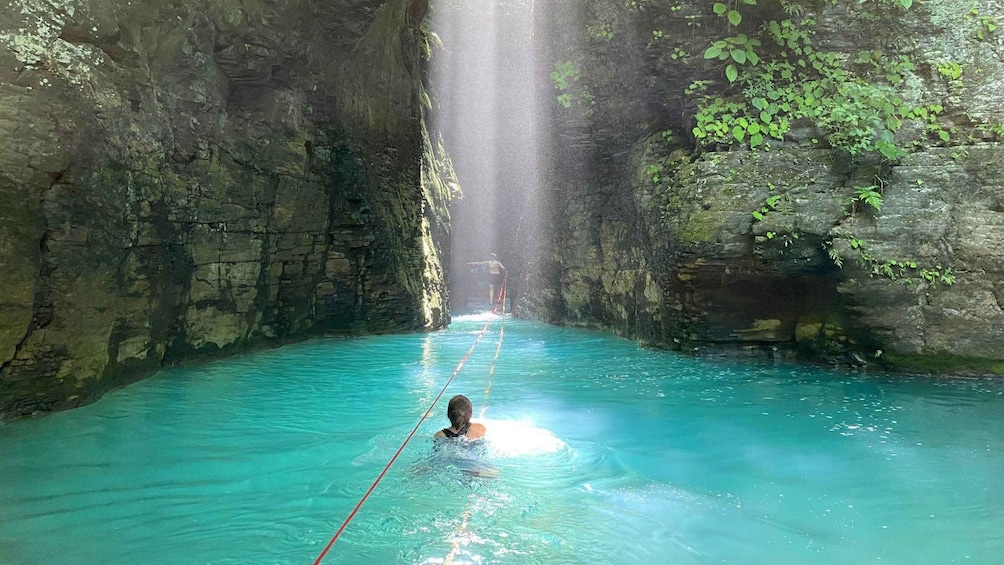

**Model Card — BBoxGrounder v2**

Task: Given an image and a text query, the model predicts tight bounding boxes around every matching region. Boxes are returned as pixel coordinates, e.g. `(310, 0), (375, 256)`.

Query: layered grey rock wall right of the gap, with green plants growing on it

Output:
(520, 0), (1004, 374)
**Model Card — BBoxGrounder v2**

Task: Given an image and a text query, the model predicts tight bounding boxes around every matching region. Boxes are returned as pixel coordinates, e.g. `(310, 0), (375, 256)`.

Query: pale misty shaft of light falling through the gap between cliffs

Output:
(421, 0), (554, 312)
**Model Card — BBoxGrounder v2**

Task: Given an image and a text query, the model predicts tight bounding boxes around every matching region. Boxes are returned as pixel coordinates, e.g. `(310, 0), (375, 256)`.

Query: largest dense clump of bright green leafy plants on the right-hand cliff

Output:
(693, 13), (914, 160)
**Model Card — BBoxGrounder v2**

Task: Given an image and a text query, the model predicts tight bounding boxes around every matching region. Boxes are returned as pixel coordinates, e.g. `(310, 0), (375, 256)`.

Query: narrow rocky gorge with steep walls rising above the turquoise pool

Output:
(0, 0), (1004, 417)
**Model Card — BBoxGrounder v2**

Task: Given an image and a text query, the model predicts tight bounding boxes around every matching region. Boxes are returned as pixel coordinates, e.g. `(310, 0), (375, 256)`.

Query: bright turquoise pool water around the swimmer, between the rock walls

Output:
(0, 317), (1004, 565)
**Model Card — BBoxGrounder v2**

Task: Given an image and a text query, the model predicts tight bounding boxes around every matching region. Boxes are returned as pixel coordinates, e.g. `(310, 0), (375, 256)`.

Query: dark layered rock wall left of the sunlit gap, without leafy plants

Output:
(0, 0), (448, 416)
